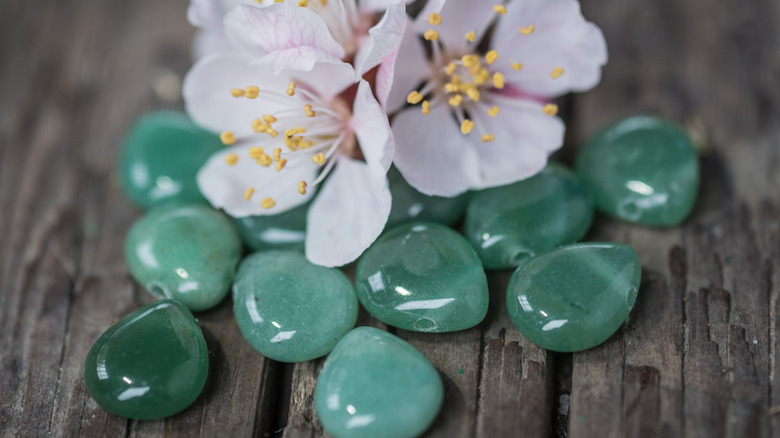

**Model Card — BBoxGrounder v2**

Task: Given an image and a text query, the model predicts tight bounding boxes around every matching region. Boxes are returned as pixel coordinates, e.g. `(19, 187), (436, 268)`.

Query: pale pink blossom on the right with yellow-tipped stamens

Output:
(386, 0), (607, 196)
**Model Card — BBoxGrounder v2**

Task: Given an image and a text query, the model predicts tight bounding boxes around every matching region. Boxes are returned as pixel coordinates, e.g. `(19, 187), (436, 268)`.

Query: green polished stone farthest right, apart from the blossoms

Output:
(577, 116), (699, 226)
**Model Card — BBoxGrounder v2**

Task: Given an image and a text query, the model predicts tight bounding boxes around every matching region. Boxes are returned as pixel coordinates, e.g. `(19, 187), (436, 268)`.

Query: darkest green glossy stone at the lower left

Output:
(84, 300), (209, 420)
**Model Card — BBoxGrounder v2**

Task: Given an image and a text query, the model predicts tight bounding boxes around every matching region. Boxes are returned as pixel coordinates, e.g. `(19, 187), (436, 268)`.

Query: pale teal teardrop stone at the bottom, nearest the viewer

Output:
(314, 327), (444, 438)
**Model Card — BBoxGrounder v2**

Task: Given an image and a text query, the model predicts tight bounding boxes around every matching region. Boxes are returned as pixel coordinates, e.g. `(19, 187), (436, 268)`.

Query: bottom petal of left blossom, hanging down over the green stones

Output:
(306, 156), (391, 266)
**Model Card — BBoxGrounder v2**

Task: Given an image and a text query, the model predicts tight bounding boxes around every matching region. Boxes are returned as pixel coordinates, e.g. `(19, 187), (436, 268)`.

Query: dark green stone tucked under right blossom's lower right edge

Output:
(465, 164), (593, 269)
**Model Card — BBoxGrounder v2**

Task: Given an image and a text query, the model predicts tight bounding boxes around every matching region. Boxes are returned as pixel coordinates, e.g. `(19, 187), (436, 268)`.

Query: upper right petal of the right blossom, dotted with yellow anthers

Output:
(491, 0), (607, 97)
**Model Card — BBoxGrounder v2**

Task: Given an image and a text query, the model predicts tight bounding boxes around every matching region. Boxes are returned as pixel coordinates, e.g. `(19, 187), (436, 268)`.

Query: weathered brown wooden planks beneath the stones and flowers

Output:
(0, 0), (780, 437)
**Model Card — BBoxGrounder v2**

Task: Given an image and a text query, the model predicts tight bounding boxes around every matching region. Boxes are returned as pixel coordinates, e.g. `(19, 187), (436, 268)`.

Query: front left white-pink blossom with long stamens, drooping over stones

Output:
(184, 52), (393, 266)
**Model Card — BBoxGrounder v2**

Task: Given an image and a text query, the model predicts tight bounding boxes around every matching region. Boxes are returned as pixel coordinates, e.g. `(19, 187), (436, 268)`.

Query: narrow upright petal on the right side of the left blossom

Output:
(350, 80), (395, 181)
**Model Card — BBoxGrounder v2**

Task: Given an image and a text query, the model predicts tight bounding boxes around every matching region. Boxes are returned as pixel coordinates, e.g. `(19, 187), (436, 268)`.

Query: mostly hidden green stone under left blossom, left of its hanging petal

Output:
(233, 203), (309, 251)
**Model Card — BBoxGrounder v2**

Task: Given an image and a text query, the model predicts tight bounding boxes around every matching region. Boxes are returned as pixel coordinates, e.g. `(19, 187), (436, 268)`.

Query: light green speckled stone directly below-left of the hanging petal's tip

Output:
(233, 251), (358, 362)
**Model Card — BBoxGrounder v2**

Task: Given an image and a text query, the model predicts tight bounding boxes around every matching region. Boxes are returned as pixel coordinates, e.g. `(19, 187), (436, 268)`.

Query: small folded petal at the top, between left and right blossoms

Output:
(355, 3), (406, 77)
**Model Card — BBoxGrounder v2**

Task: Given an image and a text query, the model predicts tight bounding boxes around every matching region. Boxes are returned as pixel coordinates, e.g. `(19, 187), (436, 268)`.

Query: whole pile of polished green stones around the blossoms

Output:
(84, 112), (699, 437)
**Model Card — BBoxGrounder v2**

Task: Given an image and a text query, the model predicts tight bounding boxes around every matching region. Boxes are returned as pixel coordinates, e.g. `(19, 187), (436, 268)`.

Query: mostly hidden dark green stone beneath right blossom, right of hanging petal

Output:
(387, 167), (468, 228)
